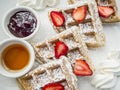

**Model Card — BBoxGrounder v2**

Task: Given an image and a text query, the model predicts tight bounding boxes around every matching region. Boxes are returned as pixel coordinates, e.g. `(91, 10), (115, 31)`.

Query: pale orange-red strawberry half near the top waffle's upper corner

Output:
(72, 6), (87, 23)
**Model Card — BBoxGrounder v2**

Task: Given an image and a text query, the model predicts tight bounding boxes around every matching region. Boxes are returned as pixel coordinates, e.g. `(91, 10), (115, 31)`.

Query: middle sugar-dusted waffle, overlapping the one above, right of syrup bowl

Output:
(34, 27), (94, 69)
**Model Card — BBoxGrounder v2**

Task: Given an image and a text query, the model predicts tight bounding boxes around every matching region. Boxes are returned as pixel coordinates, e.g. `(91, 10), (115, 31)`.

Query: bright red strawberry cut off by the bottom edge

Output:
(42, 83), (64, 90)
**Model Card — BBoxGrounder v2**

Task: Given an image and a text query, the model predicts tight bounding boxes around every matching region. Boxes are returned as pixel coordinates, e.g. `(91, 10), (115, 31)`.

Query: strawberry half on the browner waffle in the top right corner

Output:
(98, 6), (114, 18)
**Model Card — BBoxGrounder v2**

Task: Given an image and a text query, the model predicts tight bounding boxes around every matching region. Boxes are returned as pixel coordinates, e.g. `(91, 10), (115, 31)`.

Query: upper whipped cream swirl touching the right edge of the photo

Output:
(100, 51), (120, 76)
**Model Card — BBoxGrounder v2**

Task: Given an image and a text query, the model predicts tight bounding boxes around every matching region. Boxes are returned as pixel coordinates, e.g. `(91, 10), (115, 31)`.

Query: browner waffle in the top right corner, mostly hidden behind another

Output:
(68, 0), (120, 23)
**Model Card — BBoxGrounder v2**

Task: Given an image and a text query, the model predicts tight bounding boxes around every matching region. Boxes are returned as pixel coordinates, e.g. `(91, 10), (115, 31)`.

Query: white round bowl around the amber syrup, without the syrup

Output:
(0, 39), (35, 78)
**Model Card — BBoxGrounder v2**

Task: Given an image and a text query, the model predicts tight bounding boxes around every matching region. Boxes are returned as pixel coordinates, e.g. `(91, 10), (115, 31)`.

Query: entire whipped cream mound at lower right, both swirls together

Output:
(91, 51), (120, 89)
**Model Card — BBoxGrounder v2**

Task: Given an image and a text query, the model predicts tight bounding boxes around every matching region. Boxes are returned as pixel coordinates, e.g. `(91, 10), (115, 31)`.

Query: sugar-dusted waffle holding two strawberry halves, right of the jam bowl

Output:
(49, 0), (105, 48)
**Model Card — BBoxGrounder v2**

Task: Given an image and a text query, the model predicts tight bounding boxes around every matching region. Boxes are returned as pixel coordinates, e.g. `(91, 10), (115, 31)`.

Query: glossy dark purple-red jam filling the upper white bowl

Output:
(8, 11), (37, 38)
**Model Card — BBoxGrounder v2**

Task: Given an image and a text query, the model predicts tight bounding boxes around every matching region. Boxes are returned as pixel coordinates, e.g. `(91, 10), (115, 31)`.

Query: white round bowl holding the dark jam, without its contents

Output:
(2, 6), (40, 40)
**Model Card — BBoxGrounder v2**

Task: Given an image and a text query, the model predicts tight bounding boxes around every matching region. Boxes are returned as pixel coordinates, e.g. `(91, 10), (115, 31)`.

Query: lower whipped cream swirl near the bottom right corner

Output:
(91, 73), (117, 89)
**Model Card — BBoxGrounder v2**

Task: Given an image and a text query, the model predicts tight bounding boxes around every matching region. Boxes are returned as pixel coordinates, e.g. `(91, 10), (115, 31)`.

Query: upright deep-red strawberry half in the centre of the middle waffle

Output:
(54, 41), (68, 58)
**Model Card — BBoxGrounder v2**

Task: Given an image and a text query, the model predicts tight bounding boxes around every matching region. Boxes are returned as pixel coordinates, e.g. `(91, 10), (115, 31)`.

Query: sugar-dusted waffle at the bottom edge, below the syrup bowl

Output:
(17, 56), (78, 90)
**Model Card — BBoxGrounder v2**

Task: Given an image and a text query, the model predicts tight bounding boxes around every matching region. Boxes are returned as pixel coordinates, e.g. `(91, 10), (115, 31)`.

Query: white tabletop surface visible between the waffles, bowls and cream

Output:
(0, 0), (120, 90)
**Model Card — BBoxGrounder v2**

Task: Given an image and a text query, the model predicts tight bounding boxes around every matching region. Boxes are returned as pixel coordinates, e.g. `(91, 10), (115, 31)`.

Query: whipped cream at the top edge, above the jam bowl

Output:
(17, 0), (59, 10)
